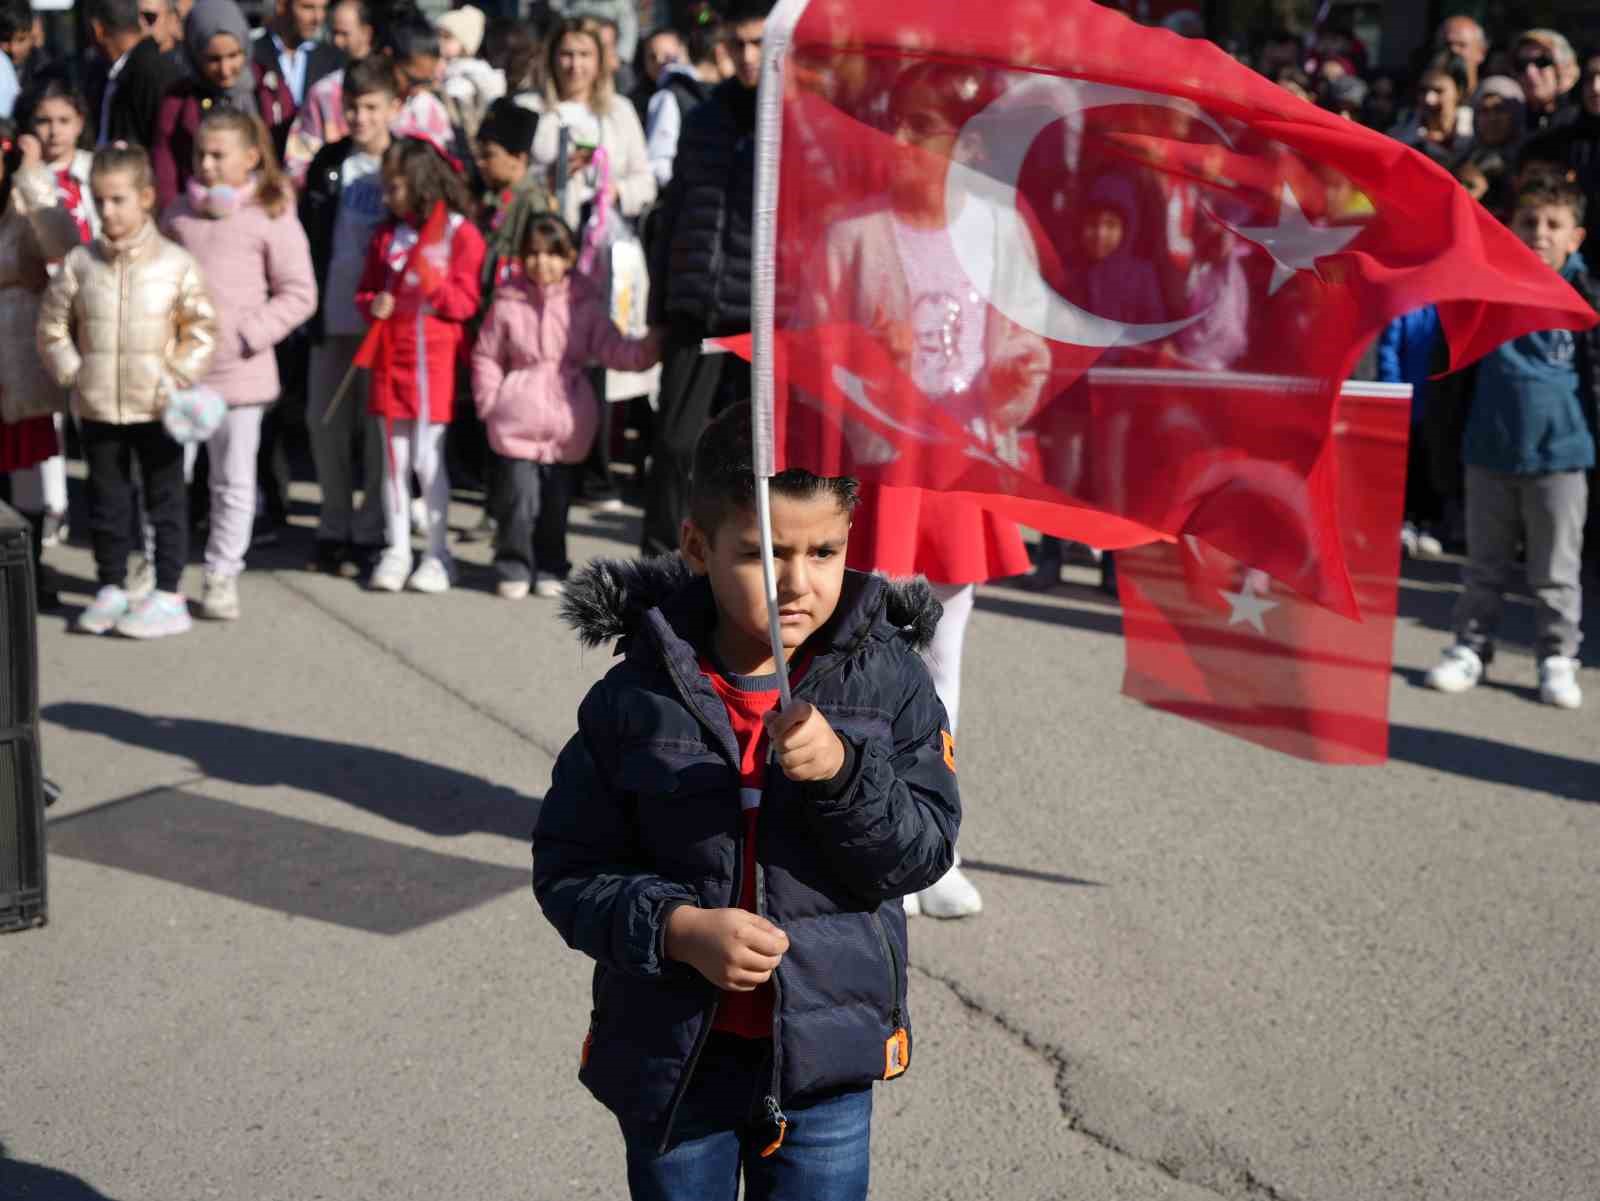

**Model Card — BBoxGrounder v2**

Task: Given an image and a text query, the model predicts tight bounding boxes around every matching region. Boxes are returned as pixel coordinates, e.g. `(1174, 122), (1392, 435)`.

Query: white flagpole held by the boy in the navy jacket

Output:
(750, 0), (806, 708)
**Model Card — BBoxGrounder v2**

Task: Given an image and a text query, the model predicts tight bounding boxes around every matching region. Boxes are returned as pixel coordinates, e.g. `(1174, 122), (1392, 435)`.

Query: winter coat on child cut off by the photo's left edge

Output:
(0, 166), (78, 422)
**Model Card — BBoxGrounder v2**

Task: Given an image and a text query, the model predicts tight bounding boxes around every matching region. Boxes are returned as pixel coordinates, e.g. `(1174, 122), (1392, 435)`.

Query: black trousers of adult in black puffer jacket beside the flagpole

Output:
(640, 337), (750, 555)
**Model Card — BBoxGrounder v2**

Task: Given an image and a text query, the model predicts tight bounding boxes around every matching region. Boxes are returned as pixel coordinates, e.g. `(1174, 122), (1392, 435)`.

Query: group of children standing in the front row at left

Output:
(0, 9), (659, 638)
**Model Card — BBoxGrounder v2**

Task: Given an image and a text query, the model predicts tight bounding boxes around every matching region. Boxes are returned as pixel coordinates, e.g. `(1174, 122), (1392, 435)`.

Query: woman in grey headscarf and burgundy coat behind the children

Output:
(150, 0), (294, 209)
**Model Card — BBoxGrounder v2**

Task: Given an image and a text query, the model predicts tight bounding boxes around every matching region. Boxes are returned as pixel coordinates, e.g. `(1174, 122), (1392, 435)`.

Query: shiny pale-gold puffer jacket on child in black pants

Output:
(38, 221), (216, 425)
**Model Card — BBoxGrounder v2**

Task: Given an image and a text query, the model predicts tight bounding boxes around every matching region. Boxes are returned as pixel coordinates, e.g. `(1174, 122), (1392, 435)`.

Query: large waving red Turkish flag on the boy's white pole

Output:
(757, 0), (1595, 616)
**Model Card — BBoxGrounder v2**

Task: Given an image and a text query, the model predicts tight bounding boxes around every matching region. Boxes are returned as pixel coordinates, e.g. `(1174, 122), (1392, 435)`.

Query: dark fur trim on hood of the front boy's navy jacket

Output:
(562, 555), (944, 651)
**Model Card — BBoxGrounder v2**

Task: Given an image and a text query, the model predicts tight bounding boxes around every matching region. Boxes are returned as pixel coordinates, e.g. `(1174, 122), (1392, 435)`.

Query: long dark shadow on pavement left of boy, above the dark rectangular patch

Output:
(40, 702), (539, 841)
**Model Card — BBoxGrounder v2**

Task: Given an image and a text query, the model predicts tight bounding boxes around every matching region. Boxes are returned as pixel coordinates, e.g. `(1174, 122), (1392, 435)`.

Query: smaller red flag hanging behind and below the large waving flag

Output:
(1117, 385), (1410, 764)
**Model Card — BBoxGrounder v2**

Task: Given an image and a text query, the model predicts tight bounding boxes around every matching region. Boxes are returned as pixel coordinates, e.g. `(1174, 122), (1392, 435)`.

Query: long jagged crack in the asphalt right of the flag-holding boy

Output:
(910, 964), (1296, 1201)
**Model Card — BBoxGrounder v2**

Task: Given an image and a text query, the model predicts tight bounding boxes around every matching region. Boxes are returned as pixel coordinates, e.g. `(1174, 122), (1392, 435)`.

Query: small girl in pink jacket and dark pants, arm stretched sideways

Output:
(472, 214), (661, 600)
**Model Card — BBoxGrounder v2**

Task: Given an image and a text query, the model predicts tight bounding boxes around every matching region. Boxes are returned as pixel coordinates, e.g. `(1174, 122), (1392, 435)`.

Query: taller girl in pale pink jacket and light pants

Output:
(165, 109), (317, 620)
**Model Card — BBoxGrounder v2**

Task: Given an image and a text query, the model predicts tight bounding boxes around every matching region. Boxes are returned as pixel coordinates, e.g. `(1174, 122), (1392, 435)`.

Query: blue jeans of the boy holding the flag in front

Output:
(627, 1031), (872, 1201)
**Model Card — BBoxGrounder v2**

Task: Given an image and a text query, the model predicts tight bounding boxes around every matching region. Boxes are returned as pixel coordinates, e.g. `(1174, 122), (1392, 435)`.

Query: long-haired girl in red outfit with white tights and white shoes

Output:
(355, 130), (483, 592)
